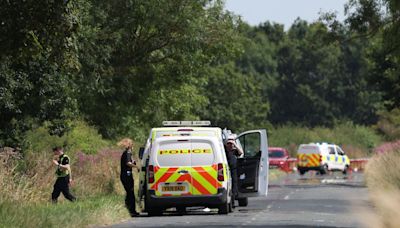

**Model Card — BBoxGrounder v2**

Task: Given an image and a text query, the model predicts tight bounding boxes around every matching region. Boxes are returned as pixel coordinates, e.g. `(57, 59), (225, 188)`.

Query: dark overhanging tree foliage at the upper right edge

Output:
(347, 0), (400, 110)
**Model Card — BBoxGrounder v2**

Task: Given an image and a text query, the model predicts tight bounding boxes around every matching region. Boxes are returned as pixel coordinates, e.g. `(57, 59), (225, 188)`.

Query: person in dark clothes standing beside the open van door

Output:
(225, 138), (243, 206)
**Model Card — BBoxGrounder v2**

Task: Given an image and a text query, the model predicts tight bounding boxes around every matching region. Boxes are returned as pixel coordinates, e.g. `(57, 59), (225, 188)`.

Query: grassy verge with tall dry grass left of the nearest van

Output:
(0, 147), (134, 227)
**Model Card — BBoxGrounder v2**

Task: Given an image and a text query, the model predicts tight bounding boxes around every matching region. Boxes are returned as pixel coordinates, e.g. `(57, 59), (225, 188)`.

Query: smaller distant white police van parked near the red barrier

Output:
(297, 143), (350, 175)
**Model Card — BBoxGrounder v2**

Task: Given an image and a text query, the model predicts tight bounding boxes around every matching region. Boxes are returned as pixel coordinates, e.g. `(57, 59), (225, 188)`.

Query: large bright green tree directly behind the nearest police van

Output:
(77, 0), (242, 137)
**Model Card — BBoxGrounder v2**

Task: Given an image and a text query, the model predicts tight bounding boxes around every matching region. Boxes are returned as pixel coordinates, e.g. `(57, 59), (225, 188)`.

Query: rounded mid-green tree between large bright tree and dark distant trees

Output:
(199, 63), (269, 131)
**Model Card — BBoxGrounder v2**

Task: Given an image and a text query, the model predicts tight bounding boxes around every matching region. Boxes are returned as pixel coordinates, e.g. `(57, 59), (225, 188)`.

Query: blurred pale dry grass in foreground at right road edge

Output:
(366, 150), (400, 228)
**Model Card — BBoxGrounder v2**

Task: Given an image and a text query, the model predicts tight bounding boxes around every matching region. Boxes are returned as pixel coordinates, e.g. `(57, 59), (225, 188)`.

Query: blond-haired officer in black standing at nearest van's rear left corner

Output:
(118, 138), (139, 217)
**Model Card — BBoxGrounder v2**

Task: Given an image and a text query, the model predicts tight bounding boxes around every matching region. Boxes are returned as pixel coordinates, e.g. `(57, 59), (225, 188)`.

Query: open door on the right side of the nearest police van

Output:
(237, 129), (269, 197)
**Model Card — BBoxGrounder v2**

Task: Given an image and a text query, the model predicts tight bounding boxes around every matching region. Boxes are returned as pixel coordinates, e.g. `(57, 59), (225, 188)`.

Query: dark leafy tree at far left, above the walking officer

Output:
(0, 0), (78, 145)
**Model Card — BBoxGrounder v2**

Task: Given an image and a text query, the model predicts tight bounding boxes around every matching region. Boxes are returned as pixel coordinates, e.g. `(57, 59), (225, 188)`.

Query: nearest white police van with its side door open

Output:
(139, 121), (268, 216)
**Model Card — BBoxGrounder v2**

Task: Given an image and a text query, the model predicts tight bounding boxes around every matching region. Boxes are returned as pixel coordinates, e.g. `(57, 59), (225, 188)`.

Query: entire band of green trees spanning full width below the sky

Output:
(0, 0), (400, 145)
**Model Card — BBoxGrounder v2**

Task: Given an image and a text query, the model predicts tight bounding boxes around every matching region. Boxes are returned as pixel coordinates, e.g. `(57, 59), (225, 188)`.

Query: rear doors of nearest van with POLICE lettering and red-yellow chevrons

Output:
(150, 137), (221, 196)
